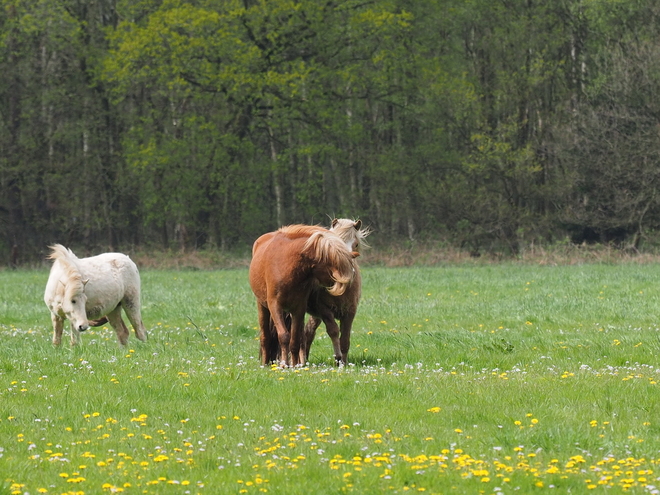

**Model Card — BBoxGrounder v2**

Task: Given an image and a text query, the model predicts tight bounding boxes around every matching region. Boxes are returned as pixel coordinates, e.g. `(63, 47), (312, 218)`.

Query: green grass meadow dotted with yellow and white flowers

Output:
(0, 264), (660, 495)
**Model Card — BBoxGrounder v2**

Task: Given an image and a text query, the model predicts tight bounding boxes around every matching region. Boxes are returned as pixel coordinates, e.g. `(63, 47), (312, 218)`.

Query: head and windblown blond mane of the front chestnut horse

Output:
(303, 230), (355, 296)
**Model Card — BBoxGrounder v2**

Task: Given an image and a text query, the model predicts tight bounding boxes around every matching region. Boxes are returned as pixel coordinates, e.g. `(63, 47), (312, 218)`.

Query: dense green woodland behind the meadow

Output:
(0, 0), (660, 265)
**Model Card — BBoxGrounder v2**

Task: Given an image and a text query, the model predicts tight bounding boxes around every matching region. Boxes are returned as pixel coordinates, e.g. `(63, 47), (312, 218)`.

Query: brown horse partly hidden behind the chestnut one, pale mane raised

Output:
(305, 218), (370, 365)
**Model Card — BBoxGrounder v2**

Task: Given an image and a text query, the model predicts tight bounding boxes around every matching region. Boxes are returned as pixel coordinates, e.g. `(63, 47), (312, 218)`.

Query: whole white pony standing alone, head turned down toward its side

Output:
(44, 244), (147, 345)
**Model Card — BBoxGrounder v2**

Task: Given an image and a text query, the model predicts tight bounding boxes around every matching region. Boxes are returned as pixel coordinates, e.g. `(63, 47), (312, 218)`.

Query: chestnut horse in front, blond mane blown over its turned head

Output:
(249, 225), (357, 366)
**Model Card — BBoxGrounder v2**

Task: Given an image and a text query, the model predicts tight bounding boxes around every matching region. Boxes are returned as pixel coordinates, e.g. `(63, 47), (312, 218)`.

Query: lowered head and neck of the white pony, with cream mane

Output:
(49, 244), (89, 332)
